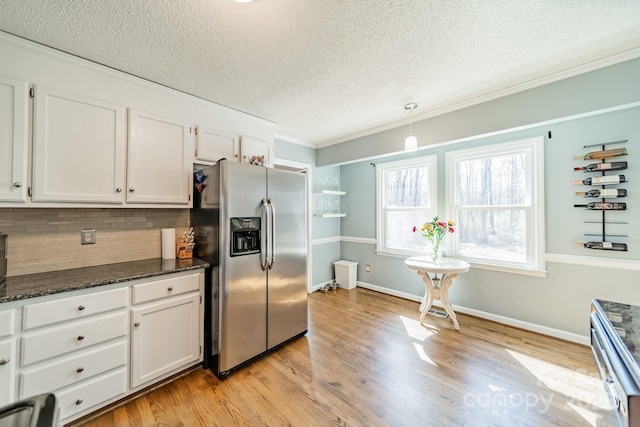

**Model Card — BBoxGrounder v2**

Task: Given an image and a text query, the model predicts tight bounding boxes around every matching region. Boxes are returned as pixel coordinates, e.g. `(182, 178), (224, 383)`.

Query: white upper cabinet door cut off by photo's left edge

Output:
(0, 75), (29, 202)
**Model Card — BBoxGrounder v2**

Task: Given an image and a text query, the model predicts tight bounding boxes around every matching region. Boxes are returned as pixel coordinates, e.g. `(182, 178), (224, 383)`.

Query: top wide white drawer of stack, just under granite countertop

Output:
(22, 288), (128, 330)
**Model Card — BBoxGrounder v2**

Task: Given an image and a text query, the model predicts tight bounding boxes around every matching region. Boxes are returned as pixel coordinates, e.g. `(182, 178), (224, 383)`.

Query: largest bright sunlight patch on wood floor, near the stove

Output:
(507, 350), (611, 425)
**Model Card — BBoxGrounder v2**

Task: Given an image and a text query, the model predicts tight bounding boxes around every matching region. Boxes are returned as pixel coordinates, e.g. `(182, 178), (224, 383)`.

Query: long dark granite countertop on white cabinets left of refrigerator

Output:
(0, 258), (209, 304)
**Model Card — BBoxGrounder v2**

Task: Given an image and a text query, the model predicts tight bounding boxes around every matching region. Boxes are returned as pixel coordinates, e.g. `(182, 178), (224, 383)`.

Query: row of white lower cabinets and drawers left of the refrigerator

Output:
(0, 270), (204, 424)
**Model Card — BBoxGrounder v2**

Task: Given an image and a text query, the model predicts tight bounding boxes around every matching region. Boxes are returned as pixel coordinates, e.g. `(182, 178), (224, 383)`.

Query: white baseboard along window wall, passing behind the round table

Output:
(357, 281), (590, 345)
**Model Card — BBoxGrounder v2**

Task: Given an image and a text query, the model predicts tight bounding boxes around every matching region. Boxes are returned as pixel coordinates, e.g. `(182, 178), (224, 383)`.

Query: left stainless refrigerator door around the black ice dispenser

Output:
(218, 162), (267, 373)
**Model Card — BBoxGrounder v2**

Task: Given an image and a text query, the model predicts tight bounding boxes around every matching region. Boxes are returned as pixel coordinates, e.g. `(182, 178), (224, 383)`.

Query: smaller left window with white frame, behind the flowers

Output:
(376, 156), (437, 256)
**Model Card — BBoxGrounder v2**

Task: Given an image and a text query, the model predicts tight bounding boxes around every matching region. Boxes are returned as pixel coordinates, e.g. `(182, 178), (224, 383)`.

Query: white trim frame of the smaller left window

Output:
(375, 154), (438, 258)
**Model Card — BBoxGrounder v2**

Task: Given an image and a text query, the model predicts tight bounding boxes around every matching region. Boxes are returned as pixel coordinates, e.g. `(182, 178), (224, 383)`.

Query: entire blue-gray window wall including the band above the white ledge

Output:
(306, 59), (640, 342)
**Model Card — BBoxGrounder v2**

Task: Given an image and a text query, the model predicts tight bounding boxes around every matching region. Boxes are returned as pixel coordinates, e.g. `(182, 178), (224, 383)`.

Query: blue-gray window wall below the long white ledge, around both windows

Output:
(341, 107), (640, 337)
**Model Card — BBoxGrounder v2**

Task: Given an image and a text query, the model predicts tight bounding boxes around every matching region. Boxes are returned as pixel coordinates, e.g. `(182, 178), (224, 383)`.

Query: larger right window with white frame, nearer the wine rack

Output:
(446, 138), (544, 271)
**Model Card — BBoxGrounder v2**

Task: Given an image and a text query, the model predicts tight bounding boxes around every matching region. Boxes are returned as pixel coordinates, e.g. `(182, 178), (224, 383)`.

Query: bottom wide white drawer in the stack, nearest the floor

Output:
(56, 367), (127, 422)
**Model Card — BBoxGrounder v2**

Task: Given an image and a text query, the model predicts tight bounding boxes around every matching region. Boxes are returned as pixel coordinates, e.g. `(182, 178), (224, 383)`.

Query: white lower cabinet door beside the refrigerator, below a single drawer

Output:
(131, 293), (201, 388)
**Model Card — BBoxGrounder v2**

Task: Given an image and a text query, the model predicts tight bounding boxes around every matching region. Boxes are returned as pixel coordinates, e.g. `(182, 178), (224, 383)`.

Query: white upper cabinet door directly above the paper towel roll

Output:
(127, 110), (192, 205)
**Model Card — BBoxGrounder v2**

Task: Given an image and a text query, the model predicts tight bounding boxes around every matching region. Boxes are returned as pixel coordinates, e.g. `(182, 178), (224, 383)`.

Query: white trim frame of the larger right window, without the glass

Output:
(445, 136), (546, 276)
